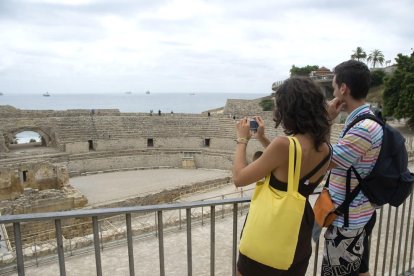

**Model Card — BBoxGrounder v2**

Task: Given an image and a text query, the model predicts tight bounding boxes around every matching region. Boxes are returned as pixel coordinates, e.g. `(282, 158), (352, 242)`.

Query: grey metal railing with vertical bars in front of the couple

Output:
(0, 192), (414, 276)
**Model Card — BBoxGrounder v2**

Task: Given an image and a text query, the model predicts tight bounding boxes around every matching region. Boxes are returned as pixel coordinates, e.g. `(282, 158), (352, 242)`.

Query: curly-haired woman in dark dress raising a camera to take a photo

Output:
(233, 77), (331, 276)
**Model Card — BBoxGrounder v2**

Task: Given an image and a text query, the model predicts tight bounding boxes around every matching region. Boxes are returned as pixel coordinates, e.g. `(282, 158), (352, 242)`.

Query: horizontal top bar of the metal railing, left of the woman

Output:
(0, 197), (250, 224)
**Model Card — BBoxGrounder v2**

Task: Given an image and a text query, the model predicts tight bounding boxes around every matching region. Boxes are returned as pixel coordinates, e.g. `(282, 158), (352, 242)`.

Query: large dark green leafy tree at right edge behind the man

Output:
(383, 53), (414, 126)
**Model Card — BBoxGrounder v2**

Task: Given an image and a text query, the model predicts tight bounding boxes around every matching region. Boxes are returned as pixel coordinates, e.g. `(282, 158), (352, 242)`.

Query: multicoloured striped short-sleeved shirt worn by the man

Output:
(329, 104), (383, 229)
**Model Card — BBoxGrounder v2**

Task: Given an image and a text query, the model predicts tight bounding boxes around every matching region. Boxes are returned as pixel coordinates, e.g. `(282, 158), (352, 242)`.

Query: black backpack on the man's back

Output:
(344, 114), (414, 207)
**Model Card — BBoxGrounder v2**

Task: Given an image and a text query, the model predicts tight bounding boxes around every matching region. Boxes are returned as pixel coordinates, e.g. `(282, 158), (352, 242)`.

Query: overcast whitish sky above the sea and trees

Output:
(0, 0), (414, 93)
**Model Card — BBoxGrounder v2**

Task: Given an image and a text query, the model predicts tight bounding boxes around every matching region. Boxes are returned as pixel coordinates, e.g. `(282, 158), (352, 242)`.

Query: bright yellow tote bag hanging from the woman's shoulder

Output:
(240, 137), (306, 270)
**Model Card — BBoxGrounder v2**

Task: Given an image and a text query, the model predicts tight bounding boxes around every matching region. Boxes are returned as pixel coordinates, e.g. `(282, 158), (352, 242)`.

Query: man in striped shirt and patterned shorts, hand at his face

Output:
(321, 60), (383, 275)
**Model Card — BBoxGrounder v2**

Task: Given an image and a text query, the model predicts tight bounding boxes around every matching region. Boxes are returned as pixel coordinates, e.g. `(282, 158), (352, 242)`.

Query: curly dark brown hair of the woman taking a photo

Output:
(274, 77), (330, 150)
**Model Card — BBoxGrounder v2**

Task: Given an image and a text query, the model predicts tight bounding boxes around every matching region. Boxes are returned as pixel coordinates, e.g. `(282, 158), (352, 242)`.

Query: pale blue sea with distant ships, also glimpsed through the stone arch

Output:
(0, 92), (270, 144)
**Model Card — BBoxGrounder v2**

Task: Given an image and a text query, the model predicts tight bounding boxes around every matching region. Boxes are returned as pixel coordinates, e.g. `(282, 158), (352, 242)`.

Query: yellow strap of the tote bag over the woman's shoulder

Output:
(287, 137), (302, 194)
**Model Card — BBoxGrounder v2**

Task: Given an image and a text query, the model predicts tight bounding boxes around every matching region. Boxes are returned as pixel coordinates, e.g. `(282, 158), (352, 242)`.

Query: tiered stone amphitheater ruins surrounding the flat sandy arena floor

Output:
(0, 91), (413, 274)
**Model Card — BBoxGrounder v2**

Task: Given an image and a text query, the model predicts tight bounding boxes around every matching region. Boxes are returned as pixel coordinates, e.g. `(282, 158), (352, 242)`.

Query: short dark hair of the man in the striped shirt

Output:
(333, 60), (371, 100)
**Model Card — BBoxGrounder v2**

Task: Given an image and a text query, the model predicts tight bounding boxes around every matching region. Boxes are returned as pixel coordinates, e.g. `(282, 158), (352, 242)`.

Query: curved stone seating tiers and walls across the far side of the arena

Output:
(0, 106), (341, 177)
